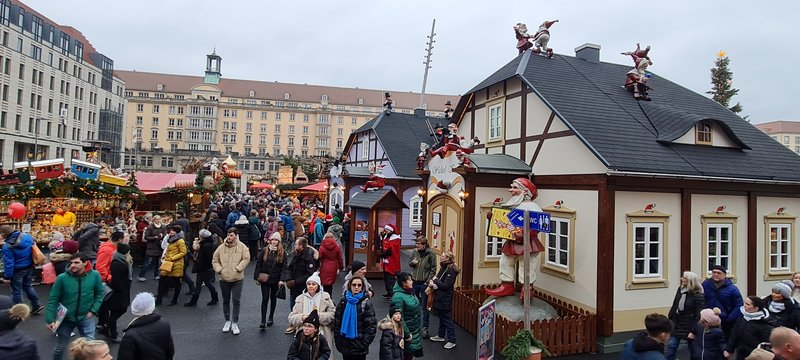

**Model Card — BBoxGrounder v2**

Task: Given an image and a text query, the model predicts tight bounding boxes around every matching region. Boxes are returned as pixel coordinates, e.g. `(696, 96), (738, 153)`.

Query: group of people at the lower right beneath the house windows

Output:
(621, 265), (800, 360)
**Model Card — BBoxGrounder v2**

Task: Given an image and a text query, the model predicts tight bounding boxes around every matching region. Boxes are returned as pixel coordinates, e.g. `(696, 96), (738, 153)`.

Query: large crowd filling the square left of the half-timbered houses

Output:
(0, 192), (459, 360)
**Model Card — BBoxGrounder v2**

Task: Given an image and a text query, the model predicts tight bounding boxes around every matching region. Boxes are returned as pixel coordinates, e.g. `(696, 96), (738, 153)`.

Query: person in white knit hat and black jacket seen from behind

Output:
(117, 292), (175, 360)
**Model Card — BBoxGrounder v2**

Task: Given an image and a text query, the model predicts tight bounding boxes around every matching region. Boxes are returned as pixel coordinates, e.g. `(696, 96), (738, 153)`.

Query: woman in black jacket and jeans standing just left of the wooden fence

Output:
(422, 250), (461, 350)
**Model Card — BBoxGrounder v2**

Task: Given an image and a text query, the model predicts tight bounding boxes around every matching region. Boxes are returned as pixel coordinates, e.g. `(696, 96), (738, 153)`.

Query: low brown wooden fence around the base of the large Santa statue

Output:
(453, 285), (597, 355)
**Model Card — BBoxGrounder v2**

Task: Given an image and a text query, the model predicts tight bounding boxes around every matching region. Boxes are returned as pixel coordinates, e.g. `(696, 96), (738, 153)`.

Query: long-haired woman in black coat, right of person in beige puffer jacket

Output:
(253, 232), (288, 330)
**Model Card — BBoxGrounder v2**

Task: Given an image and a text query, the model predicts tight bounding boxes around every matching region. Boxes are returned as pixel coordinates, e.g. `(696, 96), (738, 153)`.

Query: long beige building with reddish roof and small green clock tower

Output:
(115, 53), (458, 175)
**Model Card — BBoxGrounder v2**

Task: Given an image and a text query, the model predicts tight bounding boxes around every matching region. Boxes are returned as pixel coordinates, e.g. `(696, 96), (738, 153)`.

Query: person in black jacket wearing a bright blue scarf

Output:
(333, 276), (378, 360)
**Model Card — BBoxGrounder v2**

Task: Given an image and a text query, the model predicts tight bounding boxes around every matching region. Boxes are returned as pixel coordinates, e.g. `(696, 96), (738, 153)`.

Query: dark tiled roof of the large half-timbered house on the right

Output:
(470, 53), (800, 181)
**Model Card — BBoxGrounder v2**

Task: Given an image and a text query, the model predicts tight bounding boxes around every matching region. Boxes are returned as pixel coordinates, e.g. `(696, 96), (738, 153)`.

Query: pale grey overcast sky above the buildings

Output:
(25, 0), (800, 123)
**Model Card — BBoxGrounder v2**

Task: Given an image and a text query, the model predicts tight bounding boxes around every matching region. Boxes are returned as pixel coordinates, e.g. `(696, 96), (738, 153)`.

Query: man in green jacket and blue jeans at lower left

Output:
(45, 252), (105, 360)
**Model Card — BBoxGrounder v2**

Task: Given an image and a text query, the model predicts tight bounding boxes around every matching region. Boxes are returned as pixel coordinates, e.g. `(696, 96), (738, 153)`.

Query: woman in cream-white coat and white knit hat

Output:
(288, 273), (336, 348)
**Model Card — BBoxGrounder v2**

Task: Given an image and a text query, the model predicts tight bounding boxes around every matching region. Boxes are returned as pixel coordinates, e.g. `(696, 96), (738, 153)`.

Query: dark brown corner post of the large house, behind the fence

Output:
(597, 179), (615, 336)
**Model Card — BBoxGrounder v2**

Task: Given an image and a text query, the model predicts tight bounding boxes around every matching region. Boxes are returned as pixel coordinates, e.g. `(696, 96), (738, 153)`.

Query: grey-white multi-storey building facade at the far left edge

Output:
(0, 0), (124, 169)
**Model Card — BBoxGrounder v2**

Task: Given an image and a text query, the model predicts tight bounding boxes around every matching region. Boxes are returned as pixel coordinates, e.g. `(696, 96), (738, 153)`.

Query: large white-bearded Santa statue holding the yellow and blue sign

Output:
(485, 178), (544, 297)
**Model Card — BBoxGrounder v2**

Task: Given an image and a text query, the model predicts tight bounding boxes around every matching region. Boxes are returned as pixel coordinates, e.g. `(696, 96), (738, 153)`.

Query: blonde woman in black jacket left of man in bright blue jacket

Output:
(664, 271), (706, 360)
